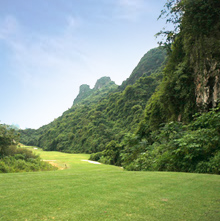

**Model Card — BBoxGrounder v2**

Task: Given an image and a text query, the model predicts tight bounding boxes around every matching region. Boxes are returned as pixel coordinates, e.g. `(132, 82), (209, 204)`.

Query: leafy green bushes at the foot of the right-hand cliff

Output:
(121, 107), (220, 174)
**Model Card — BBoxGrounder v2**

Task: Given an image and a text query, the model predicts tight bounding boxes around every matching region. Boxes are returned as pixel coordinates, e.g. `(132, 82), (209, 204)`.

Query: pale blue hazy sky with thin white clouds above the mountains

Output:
(0, 0), (166, 128)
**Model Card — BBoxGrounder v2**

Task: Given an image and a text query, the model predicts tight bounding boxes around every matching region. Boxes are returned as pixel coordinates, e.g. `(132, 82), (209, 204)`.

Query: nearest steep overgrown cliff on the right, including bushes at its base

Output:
(91, 0), (220, 174)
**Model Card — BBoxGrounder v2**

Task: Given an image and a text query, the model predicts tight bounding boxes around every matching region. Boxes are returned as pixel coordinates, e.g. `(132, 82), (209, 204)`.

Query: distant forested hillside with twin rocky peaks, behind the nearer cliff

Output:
(21, 48), (166, 153)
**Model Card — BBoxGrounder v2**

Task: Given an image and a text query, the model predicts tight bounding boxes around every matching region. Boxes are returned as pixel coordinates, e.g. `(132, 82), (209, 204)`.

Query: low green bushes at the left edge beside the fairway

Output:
(0, 125), (56, 173)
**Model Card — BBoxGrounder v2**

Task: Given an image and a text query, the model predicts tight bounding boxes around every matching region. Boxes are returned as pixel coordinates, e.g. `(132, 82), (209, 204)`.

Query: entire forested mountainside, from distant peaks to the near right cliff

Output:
(21, 0), (220, 173)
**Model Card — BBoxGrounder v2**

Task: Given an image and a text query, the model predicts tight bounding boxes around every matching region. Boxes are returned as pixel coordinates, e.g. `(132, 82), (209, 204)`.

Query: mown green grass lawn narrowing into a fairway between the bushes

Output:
(0, 146), (220, 221)
